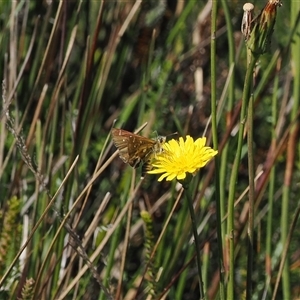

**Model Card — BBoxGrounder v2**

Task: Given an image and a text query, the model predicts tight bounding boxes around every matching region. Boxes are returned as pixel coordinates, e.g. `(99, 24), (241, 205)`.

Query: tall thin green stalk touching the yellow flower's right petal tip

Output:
(210, 1), (225, 300)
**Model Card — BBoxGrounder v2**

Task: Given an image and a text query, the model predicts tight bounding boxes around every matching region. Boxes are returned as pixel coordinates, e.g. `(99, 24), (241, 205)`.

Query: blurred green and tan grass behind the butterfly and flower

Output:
(0, 0), (300, 299)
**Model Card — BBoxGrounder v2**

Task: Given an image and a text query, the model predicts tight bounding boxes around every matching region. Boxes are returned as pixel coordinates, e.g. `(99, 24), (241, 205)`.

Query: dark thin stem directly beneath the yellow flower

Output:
(184, 186), (205, 299)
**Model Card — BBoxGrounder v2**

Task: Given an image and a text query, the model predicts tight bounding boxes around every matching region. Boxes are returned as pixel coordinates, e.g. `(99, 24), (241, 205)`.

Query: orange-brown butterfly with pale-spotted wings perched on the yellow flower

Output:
(111, 128), (166, 176)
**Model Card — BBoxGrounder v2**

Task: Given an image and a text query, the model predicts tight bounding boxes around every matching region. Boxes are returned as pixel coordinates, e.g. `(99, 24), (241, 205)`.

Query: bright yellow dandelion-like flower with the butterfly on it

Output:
(148, 135), (218, 181)
